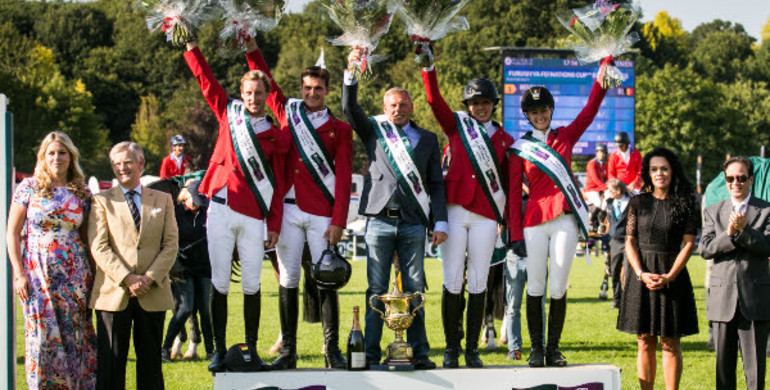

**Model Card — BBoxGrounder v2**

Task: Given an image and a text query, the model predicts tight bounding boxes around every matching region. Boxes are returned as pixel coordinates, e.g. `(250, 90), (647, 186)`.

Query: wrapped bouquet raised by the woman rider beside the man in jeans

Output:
(399, 0), (470, 68)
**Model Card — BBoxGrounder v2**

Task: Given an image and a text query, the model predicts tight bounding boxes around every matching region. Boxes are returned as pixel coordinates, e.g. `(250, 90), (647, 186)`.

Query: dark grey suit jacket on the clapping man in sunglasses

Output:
(700, 196), (770, 322)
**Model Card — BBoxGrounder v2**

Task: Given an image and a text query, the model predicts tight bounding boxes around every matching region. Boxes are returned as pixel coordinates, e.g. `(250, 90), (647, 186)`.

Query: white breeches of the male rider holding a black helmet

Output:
(276, 203), (332, 288)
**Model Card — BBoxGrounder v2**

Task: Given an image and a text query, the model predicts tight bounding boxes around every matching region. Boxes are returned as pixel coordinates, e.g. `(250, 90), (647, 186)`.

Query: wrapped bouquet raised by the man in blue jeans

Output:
(326, 0), (396, 77)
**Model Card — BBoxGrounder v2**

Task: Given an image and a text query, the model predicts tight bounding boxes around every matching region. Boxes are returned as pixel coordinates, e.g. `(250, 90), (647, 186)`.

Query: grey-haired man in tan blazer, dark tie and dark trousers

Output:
(88, 142), (178, 390)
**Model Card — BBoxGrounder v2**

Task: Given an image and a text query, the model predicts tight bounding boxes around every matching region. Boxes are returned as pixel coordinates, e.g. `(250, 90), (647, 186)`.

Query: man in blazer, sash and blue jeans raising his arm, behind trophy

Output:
(342, 50), (447, 369)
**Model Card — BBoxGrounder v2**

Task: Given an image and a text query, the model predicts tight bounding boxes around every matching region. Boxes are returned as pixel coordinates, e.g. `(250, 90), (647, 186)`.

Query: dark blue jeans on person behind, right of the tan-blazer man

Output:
(163, 277), (214, 352)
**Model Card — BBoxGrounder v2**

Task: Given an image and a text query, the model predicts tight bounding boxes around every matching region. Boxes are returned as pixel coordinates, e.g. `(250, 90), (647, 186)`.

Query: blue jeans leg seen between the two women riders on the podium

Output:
(505, 254), (527, 352)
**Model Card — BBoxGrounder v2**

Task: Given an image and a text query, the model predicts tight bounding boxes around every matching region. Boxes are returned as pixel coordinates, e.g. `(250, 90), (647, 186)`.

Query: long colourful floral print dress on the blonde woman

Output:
(13, 178), (96, 390)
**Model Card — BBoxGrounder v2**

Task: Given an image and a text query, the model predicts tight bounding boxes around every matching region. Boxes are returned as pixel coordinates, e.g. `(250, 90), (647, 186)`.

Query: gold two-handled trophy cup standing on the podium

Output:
(369, 279), (425, 371)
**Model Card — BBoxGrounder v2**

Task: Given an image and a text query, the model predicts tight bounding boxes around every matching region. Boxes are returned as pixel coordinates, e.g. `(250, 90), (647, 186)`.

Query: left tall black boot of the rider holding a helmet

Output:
(270, 286), (299, 370)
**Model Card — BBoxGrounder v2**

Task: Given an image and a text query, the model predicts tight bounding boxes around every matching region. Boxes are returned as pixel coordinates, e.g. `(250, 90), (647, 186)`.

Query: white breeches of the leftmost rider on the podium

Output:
(206, 202), (265, 295)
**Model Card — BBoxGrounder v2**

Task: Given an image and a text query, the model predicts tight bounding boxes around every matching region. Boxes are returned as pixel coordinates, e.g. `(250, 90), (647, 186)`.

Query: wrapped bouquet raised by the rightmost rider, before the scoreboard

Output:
(556, 0), (641, 88)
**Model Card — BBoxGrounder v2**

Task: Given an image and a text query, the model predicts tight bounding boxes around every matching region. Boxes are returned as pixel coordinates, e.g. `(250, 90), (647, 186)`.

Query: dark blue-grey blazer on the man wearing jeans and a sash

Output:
(342, 84), (447, 228)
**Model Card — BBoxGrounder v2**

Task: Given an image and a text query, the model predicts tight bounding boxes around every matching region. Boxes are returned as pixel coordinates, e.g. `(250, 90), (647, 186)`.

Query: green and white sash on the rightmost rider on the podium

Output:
(511, 134), (588, 240)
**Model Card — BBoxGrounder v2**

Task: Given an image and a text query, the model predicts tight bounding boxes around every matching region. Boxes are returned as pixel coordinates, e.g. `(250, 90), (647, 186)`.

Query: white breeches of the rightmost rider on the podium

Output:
(524, 214), (578, 299)
